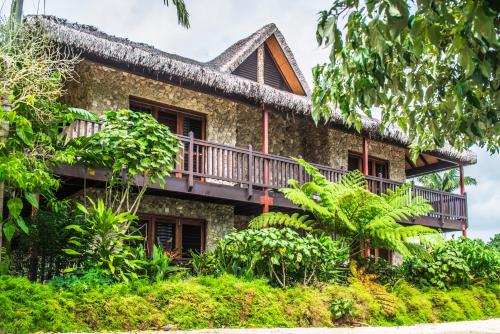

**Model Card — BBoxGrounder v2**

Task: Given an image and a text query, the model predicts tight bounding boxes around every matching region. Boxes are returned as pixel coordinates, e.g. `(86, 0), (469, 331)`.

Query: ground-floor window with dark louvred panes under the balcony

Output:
(140, 215), (205, 258)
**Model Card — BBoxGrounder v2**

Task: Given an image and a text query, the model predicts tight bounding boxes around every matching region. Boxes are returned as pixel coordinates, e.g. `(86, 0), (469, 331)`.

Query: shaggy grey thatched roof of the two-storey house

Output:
(26, 16), (476, 164)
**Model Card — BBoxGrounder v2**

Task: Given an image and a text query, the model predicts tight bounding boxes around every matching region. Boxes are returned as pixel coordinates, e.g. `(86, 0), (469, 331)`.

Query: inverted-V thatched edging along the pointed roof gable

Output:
(207, 23), (310, 95)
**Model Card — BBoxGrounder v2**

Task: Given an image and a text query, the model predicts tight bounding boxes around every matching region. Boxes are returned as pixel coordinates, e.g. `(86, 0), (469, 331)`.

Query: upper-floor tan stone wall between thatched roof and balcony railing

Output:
(65, 61), (405, 181)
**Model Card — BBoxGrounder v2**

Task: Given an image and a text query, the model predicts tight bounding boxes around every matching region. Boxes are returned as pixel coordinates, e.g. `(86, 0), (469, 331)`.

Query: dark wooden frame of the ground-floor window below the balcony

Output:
(137, 212), (207, 259)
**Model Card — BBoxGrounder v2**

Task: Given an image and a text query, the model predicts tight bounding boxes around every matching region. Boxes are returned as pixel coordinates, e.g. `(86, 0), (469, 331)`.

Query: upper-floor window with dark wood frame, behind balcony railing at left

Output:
(129, 97), (205, 139)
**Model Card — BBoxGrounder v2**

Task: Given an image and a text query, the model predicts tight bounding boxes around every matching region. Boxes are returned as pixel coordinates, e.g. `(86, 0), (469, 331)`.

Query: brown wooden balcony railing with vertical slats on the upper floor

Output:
(63, 120), (467, 223)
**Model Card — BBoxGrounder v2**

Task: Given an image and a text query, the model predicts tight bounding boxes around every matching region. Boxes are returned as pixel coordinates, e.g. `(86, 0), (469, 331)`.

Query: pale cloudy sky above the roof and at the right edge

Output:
(0, 0), (500, 241)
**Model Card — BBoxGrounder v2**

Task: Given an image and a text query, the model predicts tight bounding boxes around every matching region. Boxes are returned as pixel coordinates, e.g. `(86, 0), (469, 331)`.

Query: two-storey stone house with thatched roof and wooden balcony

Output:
(27, 16), (476, 254)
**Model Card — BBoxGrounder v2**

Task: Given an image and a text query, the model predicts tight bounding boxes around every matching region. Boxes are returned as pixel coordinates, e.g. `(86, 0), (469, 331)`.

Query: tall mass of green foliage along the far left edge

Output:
(0, 17), (95, 268)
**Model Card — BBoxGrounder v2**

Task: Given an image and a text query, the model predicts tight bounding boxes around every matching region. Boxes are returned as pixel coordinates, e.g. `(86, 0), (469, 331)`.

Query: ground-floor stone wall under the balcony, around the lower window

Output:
(72, 188), (235, 249)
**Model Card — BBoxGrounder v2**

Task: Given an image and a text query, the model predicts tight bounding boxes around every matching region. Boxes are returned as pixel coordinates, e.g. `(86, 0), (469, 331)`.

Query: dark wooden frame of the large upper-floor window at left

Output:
(128, 95), (207, 140)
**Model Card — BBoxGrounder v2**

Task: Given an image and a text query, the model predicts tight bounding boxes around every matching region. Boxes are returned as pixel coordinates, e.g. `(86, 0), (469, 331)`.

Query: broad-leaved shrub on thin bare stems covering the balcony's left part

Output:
(70, 110), (181, 214)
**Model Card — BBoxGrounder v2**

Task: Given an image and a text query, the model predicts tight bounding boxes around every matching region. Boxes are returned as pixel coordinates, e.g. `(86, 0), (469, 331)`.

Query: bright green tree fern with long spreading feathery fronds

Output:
(250, 159), (437, 256)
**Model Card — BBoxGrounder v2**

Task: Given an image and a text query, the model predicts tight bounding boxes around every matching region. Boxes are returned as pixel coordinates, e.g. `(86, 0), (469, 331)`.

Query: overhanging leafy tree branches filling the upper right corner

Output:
(313, 0), (500, 158)
